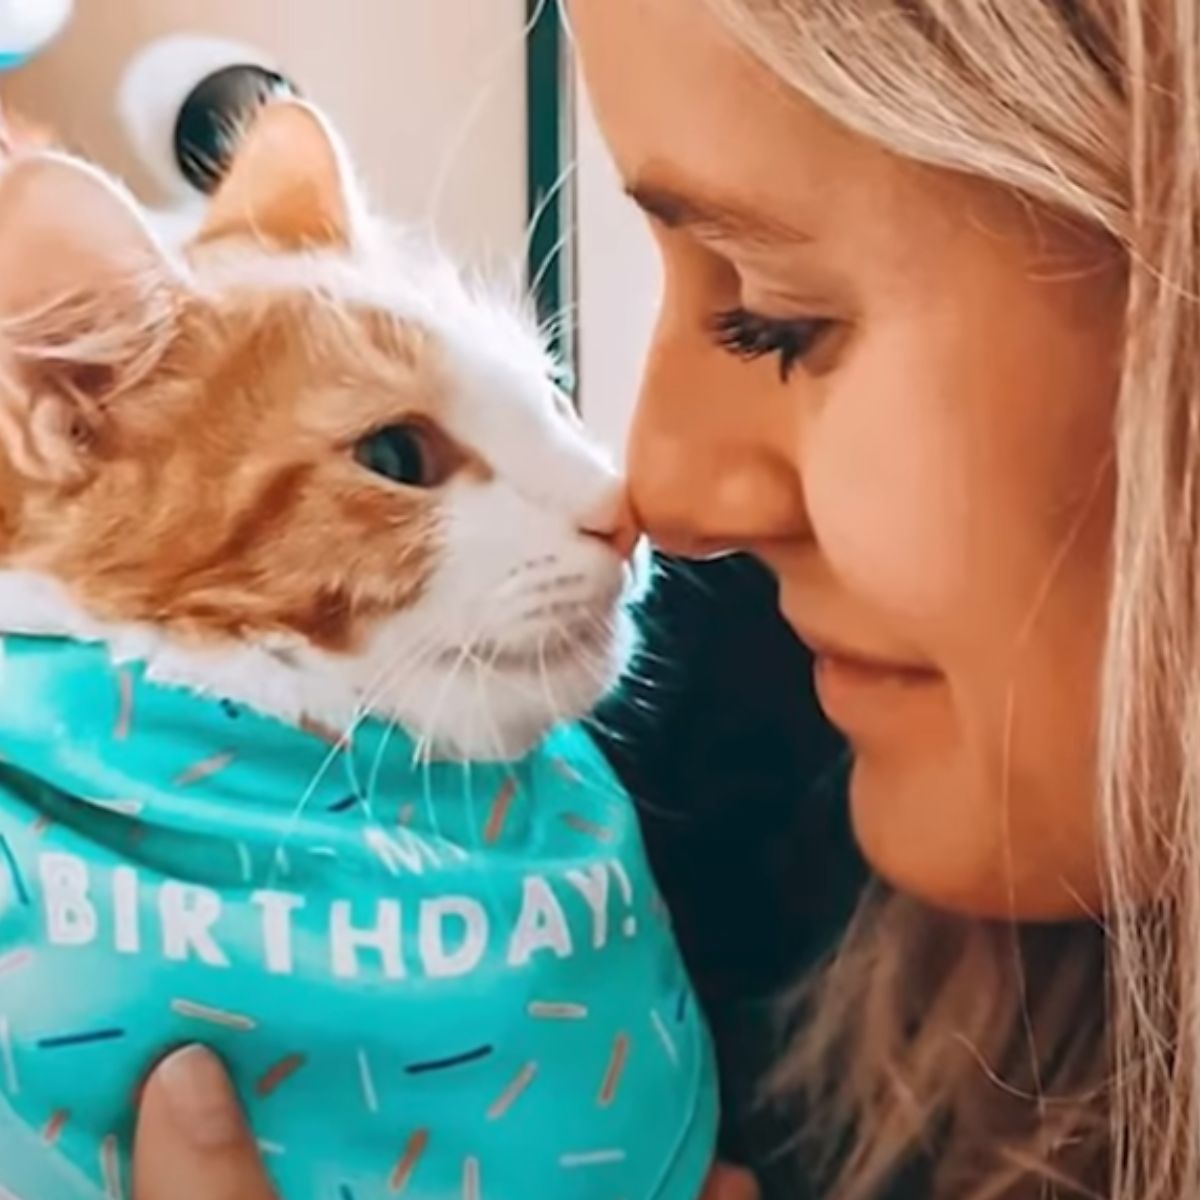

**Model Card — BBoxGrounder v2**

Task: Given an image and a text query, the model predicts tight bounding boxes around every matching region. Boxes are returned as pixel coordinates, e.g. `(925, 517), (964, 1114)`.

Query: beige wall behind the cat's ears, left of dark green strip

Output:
(5, 0), (526, 257)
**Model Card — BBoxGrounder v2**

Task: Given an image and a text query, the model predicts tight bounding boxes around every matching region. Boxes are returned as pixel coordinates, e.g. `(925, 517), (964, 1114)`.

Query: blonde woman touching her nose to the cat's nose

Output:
(142, 0), (1200, 1200)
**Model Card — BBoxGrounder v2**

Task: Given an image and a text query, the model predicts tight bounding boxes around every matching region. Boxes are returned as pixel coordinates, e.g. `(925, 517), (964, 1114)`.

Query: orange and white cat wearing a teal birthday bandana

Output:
(0, 101), (719, 1200)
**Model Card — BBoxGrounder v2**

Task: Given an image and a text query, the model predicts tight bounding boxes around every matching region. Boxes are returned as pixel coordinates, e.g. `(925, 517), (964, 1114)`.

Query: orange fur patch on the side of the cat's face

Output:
(5, 284), (453, 650)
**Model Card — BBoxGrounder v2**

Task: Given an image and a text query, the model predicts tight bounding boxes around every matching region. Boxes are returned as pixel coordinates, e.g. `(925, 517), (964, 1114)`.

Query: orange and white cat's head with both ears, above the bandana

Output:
(0, 106), (632, 757)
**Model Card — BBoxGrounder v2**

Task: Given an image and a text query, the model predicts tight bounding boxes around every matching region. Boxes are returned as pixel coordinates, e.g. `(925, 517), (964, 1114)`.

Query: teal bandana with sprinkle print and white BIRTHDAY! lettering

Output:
(0, 637), (716, 1200)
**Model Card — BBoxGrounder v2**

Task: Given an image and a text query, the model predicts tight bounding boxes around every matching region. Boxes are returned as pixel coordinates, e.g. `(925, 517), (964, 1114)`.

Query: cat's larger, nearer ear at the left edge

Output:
(0, 152), (187, 481)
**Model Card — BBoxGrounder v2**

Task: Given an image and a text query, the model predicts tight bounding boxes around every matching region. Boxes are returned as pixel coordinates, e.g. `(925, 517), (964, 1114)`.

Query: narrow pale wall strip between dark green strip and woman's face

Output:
(575, 79), (662, 450)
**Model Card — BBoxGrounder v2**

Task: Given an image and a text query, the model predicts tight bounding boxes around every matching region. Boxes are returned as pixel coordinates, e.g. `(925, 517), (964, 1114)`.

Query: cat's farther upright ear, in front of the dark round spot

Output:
(196, 98), (365, 251)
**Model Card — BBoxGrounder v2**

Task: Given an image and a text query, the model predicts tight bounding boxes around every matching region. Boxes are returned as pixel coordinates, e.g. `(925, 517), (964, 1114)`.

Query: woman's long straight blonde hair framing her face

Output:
(707, 0), (1200, 1200)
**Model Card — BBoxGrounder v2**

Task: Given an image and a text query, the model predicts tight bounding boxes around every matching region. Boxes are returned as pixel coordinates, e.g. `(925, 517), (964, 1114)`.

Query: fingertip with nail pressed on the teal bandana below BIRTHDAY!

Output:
(133, 1046), (275, 1200)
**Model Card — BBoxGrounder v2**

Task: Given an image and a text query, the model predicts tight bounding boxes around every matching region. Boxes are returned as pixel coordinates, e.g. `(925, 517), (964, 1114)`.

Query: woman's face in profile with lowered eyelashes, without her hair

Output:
(571, 0), (1123, 919)
